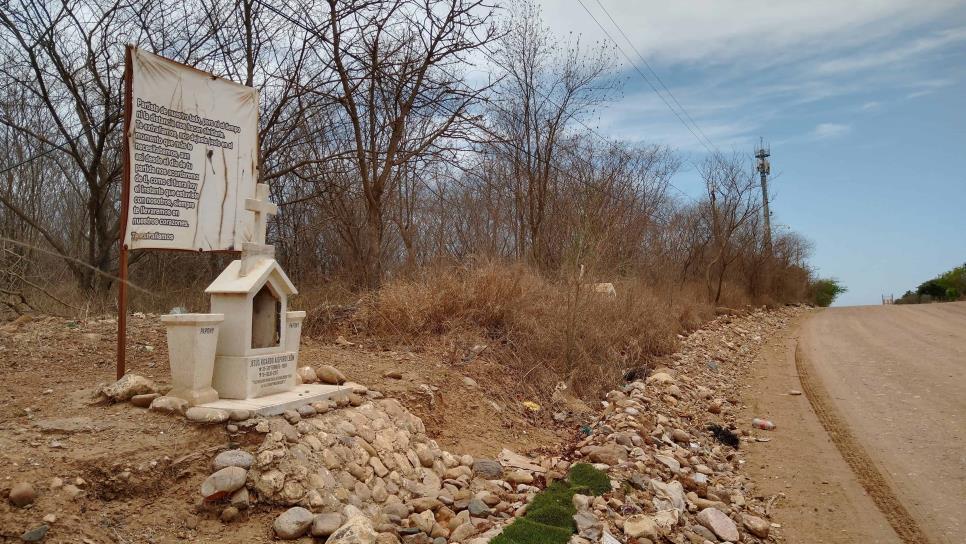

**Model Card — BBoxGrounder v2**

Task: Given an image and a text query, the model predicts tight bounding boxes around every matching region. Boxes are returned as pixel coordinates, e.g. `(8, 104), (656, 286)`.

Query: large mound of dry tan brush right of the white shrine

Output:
(351, 261), (711, 398)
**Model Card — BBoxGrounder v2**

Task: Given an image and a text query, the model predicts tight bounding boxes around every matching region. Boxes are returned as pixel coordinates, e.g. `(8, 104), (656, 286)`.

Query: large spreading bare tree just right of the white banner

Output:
(284, 0), (494, 286)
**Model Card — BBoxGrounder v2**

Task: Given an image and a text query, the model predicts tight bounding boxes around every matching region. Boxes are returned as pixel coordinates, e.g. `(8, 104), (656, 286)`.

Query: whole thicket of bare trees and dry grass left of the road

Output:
(0, 0), (816, 395)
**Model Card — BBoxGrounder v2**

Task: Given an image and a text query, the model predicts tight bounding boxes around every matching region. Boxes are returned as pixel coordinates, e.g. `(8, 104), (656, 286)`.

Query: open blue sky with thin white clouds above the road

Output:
(540, 0), (966, 305)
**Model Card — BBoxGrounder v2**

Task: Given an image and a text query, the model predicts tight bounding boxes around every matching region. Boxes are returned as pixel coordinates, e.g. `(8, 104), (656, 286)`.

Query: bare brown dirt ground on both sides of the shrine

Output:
(0, 315), (587, 544)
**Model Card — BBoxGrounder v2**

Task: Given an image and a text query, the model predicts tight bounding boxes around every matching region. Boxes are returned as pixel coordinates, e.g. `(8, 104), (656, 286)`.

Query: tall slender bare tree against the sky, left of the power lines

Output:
(491, 1), (616, 266)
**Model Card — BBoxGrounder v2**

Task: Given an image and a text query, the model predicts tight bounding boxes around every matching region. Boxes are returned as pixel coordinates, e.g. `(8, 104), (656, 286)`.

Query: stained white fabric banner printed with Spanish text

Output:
(124, 47), (258, 251)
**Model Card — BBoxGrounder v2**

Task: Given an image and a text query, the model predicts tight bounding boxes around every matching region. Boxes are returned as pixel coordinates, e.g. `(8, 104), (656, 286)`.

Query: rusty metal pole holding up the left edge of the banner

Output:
(117, 45), (133, 379)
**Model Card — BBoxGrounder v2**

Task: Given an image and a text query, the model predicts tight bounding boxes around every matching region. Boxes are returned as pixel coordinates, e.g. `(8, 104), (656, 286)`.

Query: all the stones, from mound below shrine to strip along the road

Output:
(189, 308), (801, 544)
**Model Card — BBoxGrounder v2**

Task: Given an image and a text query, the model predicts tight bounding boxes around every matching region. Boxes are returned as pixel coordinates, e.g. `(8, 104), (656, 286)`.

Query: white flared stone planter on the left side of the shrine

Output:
(161, 314), (225, 406)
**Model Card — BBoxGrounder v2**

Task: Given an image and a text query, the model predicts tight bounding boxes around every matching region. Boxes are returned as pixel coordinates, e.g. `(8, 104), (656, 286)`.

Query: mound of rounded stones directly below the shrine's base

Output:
(241, 399), (543, 544)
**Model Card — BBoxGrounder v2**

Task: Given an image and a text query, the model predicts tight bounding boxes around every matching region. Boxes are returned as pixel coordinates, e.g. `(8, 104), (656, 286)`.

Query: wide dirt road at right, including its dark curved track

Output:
(799, 303), (966, 544)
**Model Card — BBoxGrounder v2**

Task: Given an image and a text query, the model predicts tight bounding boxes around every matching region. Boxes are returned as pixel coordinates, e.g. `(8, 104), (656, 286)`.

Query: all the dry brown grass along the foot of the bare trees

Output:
(5, 260), (747, 399)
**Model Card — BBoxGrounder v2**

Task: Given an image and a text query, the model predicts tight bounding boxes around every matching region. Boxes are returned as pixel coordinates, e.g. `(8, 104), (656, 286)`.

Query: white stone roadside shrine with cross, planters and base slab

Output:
(162, 184), (349, 415)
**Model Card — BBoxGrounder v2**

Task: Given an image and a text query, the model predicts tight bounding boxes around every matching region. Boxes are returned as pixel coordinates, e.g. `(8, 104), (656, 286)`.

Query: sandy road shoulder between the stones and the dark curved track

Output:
(742, 314), (901, 544)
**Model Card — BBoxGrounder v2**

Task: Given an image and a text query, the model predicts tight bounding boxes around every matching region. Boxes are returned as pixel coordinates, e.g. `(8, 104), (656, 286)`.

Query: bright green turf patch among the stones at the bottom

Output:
(491, 463), (610, 544)
